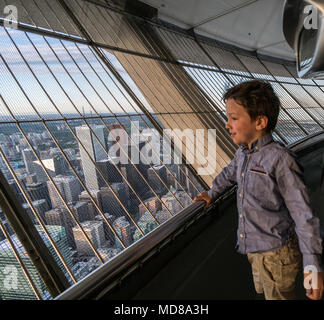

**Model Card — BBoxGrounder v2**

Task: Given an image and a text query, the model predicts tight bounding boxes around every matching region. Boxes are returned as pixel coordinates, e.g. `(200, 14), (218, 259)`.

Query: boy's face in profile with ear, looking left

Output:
(226, 99), (267, 147)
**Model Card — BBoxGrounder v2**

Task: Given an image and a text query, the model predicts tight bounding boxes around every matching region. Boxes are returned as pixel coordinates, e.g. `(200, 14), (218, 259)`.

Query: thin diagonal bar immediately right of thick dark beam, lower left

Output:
(0, 134), (76, 283)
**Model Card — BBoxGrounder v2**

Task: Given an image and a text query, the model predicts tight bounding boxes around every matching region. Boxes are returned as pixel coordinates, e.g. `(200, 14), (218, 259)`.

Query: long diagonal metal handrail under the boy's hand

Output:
(55, 186), (236, 300)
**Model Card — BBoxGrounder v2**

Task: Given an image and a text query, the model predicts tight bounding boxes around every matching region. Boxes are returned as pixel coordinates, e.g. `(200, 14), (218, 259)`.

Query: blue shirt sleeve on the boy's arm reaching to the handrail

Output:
(208, 153), (237, 201)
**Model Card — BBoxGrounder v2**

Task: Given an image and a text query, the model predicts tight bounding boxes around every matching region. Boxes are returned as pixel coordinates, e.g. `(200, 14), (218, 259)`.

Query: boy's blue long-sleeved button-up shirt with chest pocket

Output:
(208, 134), (323, 271)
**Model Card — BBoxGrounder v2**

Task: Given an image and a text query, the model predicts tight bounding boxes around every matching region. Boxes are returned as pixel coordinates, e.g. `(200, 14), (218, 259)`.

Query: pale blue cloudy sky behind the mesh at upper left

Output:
(0, 27), (151, 118)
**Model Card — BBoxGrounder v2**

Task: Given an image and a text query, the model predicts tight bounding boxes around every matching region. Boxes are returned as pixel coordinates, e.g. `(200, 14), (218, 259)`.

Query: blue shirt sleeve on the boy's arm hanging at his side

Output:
(276, 152), (323, 272)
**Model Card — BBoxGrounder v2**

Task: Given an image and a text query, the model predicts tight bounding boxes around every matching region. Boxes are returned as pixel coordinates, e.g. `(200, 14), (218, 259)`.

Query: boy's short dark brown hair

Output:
(223, 80), (280, 132)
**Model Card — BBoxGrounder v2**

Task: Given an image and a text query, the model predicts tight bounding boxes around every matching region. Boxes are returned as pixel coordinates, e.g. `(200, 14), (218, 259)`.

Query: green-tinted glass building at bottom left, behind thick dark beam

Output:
(0, 226), (72, 300)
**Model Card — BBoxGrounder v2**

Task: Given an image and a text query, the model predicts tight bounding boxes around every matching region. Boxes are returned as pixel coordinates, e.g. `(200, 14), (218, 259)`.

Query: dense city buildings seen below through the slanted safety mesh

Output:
(0, 117), (197, 298)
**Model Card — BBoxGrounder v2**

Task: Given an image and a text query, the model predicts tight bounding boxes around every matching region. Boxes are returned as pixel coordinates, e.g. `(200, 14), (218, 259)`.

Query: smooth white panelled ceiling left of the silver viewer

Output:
(141, 0), (295, 60)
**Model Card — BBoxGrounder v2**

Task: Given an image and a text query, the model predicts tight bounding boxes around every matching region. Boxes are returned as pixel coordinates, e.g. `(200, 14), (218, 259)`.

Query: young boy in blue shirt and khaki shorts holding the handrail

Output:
(194, 80), (323, 300)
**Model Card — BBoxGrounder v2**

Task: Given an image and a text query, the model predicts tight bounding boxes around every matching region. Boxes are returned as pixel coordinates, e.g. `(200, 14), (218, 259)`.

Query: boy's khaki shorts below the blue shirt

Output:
(247, 238), (302, 300)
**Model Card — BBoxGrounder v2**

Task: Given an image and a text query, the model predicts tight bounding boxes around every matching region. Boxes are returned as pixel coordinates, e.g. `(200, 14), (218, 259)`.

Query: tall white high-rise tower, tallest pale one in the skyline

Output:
(76, 125), (107, 190)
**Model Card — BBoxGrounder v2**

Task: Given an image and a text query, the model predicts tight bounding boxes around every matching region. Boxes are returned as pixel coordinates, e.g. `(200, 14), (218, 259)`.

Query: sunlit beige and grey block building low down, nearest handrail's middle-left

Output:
(73, 221), (106, 256)
